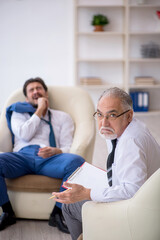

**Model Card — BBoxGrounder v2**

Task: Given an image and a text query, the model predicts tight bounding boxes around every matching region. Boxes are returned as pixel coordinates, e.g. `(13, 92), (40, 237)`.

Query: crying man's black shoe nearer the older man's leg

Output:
(48, 213), (70, 234)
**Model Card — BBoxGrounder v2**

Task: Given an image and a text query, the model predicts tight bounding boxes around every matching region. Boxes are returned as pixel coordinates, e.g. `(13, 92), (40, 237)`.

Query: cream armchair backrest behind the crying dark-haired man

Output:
(0, 86), (95, 163)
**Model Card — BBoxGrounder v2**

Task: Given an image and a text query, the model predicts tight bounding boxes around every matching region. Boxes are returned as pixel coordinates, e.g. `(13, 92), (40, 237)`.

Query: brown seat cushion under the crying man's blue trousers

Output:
(6, 174), (62, 193)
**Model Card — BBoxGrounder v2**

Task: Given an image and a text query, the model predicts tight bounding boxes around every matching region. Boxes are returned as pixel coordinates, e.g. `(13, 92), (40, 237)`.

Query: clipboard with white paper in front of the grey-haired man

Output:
(63, 162), (109, 189)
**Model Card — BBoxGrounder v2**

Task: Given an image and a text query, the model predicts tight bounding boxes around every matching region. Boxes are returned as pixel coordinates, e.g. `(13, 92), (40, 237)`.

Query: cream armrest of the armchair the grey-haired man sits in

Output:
(82, 200), (132, 240)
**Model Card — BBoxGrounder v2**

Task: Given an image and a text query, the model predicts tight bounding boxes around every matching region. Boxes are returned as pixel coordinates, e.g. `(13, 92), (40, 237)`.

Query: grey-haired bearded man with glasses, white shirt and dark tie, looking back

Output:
(53, 88), (160, 240)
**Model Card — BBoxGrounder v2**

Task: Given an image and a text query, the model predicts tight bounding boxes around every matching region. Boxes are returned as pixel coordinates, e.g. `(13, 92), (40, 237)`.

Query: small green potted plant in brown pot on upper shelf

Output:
(91, 14), (109, 32)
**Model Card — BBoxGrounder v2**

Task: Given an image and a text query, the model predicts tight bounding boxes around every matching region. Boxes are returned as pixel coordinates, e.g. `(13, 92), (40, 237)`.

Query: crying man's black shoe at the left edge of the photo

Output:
(0, 212), (16, 231)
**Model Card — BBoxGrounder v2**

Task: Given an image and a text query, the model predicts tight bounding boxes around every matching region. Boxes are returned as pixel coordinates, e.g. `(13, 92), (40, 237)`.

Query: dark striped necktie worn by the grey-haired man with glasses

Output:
(107, 139), (117, 186)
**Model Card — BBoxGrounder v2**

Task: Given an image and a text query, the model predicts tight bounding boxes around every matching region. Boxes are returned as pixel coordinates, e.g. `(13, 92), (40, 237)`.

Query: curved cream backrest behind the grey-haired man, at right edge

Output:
(127, 169), (160, 240)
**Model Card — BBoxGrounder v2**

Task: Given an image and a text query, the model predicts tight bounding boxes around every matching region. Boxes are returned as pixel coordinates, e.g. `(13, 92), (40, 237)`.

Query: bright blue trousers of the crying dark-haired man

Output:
(0, 145), (84, 207)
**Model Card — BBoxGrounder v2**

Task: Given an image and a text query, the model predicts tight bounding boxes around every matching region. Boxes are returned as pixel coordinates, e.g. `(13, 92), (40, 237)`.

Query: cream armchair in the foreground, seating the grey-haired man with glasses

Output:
(82, 169), (160, 240)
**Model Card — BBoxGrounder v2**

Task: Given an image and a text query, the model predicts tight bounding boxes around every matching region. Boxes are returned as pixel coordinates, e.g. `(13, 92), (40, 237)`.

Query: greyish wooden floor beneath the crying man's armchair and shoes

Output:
(0, 219), (71, 240)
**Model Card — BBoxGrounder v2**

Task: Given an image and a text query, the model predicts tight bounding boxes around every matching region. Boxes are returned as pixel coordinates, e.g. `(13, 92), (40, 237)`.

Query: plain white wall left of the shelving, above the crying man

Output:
(0, 0), (74, 112)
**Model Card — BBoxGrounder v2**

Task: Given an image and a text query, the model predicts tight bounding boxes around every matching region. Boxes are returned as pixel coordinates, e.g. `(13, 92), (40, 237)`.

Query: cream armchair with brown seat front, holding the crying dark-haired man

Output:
(0, 86), (95, 219)
